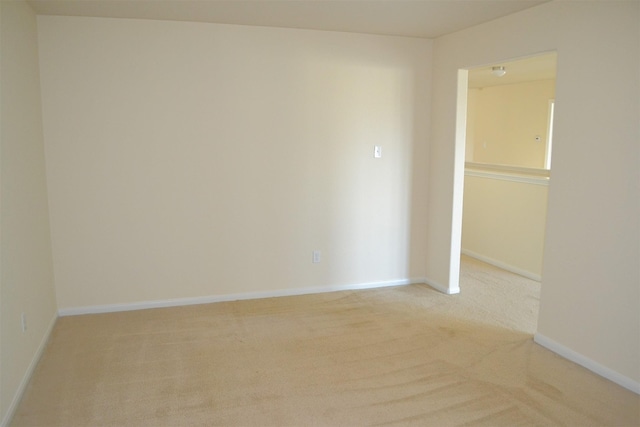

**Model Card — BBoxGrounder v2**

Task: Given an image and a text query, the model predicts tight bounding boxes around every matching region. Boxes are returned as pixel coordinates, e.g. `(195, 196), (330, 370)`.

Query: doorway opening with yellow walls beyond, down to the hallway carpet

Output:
(458, 52), (557, 288)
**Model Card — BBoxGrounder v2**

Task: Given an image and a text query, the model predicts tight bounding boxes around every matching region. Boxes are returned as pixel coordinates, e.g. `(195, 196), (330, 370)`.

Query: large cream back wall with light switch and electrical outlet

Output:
(38, 16), (432, 309)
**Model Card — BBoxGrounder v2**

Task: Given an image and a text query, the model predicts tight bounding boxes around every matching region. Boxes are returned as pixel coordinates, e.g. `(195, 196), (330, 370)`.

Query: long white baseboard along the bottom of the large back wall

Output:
(58, 277), (425, 316)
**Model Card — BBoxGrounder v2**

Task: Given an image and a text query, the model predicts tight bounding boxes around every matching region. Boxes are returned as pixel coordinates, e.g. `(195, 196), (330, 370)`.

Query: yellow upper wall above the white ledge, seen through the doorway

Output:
(466, 80), (555, 169)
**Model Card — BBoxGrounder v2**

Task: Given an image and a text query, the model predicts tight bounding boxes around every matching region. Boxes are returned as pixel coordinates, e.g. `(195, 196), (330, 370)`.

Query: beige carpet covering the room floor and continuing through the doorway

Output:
(12, 258), (640, 426)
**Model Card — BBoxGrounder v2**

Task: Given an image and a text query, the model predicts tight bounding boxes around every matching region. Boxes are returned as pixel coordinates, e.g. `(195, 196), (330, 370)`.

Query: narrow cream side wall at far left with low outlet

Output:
(0, 1), (56, 425)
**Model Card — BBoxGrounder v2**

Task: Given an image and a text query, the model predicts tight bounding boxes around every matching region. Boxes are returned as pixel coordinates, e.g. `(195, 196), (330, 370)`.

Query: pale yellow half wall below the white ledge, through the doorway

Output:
(462, 174), (548, 280)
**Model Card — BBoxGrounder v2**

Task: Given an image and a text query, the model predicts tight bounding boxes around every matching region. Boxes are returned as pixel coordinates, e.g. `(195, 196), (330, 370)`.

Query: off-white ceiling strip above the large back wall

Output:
(23, 0), (549, 38)
